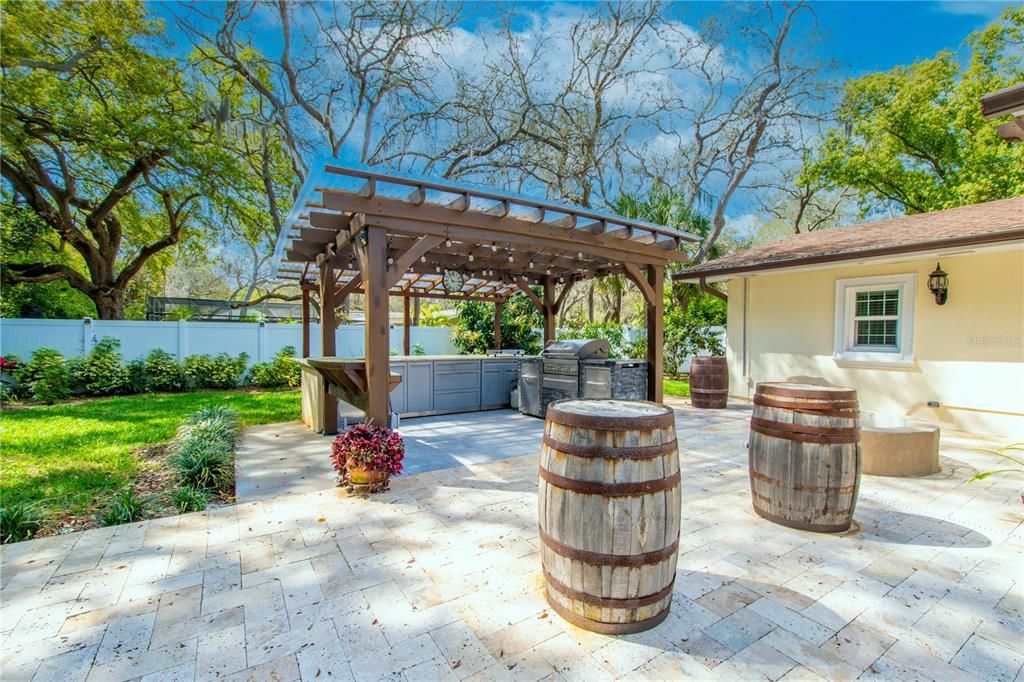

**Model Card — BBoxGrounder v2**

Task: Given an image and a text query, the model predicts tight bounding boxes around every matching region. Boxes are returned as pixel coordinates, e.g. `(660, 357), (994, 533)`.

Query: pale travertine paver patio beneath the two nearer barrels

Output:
(0, 409), (1024, 682)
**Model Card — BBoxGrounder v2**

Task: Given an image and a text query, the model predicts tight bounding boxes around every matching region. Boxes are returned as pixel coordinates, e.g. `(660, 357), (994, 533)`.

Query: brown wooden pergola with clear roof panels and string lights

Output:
(274, 159), (696, 424)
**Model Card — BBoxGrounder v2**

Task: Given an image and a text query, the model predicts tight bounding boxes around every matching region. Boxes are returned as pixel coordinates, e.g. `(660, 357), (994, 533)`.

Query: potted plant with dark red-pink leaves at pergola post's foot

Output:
(331, 424), (406, 493)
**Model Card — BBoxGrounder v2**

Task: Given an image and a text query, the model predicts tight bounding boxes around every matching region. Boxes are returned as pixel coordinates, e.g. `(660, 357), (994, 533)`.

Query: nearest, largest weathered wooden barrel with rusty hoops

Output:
(538, 400), (681, 634)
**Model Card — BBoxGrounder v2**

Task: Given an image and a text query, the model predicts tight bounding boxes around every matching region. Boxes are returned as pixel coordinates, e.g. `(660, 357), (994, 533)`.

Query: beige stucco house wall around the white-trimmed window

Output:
(727, 248), (1024, 436)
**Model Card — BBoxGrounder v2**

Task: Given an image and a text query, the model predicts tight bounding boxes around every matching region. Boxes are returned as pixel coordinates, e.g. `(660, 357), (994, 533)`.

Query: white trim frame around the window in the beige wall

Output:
(833, 272), (918, 368)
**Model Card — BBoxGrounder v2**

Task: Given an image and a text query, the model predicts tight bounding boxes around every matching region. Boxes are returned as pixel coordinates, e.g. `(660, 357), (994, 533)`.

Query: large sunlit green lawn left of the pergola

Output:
(0, 390), (299, 515)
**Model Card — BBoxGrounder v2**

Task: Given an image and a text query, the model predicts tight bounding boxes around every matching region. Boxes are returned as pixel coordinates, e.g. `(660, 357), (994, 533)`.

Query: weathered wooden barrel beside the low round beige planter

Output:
(750, 383), (860, 532)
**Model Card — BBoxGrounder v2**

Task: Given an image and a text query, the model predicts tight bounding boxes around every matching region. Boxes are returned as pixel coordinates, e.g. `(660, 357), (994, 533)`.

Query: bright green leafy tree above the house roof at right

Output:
(803, 7), (1024, 213)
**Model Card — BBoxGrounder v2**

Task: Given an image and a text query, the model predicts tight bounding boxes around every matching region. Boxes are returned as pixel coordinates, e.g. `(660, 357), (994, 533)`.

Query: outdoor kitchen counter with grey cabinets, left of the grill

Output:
(299, 355), (520, 431)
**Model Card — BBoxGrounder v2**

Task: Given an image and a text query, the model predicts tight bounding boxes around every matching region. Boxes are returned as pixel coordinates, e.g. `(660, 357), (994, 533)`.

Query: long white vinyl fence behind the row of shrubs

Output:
(0, 317), (459, 364)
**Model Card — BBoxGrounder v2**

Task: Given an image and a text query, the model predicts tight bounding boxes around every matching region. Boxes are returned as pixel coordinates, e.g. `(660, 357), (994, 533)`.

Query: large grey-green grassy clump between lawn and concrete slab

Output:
(168, 408), (239, 491)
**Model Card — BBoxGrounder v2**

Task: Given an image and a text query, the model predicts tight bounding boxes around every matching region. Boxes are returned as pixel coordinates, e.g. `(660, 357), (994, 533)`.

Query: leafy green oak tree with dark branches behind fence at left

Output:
(0, 1), (238, 319)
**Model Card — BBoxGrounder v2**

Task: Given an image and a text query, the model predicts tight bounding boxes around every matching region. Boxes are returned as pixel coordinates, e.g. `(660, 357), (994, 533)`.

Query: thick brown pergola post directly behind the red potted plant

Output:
(356, 227), (391, 426)
